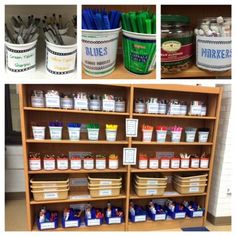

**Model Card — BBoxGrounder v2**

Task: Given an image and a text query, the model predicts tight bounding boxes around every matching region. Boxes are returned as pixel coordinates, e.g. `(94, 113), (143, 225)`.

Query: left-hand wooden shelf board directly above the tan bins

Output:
(28, 167), (128, 174)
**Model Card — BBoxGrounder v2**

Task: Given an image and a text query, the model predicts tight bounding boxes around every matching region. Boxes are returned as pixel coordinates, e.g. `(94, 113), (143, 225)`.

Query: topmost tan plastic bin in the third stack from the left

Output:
(135, 174), (167, 185)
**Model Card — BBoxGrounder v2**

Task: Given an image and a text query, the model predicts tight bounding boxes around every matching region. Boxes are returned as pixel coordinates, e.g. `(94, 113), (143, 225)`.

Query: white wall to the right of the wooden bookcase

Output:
(209, 85), (233, 217)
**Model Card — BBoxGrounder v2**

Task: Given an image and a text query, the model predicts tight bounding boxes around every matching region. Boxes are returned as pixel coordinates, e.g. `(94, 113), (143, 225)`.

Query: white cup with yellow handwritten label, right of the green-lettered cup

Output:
(46, 36), (77, 76)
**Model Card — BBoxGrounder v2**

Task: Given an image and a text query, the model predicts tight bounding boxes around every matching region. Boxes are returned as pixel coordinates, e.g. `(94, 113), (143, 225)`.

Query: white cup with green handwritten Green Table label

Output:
(5, 40), (37, 75)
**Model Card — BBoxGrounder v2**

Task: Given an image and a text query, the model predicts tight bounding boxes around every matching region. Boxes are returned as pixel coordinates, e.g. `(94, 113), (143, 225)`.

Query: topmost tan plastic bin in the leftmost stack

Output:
(30, 175), (69, 188)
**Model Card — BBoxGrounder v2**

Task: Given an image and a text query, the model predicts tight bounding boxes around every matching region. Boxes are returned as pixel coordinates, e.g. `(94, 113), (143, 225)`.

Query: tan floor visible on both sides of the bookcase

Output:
(5, 200), (231, 231)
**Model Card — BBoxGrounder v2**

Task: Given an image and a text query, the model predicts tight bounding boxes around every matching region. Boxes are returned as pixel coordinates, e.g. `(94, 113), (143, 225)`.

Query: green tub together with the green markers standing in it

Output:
(122, 11), (156, 74)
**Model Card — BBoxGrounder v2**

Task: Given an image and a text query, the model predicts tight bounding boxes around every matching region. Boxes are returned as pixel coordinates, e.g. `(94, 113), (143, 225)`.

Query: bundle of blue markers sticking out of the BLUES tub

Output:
(82, 8), (121, 30)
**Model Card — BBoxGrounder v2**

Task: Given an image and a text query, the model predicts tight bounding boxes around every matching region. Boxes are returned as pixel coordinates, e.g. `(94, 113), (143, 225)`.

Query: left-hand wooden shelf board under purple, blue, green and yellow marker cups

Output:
(26, 139), (128, 145)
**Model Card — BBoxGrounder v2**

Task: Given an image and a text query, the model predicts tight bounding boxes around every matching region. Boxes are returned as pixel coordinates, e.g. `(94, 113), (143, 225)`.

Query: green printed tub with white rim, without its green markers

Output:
(122, 30), (156, 74)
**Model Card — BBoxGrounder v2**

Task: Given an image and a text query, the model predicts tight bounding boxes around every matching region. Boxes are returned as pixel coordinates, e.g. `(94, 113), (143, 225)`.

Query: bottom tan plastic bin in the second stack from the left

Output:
(88, 184), (121, 197)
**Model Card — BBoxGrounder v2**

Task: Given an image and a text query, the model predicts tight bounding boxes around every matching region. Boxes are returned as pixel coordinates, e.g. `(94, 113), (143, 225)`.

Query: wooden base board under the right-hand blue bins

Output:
(128, 217), (204, 231)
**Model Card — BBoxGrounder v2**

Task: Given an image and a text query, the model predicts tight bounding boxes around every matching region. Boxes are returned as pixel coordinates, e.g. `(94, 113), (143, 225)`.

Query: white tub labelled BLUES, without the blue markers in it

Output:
(82, 28), (121, 77)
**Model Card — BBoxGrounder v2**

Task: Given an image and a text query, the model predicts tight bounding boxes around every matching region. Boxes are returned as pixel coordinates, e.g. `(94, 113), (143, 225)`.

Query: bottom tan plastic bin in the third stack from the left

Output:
(134, 185), (166, 197)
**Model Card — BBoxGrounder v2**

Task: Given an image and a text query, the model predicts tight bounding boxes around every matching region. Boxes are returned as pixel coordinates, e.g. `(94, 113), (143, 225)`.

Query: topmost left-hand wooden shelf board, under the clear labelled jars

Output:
(24, 107), (129, 116)
